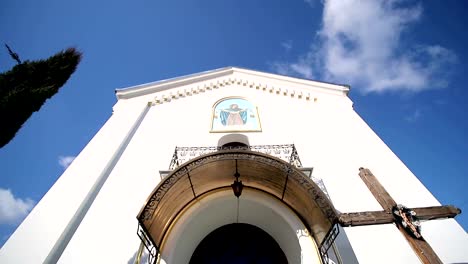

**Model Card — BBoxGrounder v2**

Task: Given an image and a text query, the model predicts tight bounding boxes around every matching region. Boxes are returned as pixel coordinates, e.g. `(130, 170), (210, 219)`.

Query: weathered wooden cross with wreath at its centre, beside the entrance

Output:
(339, 168), (461, 263)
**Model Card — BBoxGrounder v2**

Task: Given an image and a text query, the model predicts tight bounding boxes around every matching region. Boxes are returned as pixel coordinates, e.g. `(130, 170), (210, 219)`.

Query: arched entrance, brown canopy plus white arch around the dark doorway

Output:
(138, 149), (338, 263)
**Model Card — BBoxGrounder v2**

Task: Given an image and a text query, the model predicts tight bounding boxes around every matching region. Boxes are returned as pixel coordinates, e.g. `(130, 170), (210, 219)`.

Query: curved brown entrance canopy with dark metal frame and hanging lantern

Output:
(137, 147), (338, 262)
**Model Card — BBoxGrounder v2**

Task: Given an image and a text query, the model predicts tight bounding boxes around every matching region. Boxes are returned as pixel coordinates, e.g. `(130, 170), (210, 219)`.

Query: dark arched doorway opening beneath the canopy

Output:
(190, 224), (288, 264)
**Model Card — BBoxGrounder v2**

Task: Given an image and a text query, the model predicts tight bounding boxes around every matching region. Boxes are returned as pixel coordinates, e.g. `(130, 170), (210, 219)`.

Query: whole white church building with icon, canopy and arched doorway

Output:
(0, 67), (468, 264)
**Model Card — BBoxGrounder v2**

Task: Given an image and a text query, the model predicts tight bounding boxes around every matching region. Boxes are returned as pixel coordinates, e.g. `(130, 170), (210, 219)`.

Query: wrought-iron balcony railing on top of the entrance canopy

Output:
(169, 144), (302, 170)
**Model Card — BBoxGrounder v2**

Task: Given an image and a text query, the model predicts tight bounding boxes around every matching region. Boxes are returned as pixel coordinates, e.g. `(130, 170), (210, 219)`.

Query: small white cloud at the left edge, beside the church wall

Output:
(0, 188), (35, 224)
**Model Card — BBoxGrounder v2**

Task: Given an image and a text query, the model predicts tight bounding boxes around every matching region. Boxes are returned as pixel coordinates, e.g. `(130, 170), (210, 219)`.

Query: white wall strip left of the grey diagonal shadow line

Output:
(0, 98), (146, 263)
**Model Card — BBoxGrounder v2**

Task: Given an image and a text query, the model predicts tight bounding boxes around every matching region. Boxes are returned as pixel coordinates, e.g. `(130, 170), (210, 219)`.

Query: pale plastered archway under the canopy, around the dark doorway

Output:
(155, 188), (320, 264)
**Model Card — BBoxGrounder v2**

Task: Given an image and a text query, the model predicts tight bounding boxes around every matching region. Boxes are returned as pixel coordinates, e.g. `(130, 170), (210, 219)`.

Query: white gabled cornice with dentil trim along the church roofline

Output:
(112, 67), (349, 103)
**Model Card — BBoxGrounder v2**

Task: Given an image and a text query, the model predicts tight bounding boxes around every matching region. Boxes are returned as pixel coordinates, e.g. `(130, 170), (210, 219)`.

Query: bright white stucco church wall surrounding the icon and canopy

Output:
(0, 67), (468, 264)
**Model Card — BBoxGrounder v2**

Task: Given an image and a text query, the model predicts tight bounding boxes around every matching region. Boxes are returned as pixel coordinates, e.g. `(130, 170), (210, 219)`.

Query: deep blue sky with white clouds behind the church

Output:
(0, 0), (468, 248)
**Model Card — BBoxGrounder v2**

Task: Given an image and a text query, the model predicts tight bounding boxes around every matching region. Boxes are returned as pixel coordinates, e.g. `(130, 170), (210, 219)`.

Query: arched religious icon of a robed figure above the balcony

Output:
(211, 97), (262, 132)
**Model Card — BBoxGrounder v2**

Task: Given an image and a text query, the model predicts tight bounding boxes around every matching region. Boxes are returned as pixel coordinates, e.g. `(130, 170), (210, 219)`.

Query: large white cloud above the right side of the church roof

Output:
(272, 0), (457, 93)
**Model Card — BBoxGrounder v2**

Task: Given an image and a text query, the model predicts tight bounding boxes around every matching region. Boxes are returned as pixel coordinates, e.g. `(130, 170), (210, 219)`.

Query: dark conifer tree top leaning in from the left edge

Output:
(0, 48), (81, 148)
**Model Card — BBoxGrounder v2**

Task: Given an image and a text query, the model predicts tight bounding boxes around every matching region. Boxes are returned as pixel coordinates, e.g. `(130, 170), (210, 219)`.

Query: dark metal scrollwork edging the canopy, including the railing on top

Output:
(138, 144), (339, 263)
